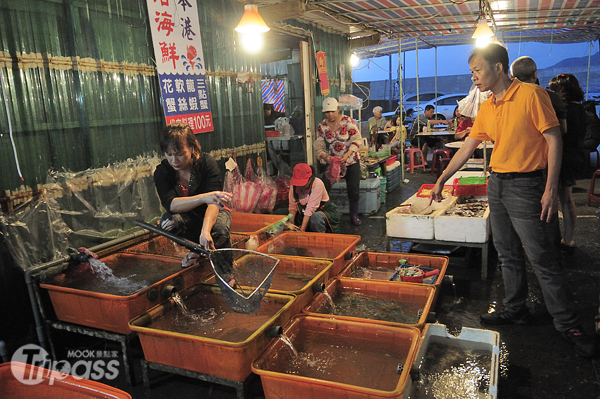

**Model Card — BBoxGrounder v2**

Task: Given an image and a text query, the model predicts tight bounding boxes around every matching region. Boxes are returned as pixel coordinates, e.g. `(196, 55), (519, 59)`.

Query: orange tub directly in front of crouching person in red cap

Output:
(257, 231), (360, 276)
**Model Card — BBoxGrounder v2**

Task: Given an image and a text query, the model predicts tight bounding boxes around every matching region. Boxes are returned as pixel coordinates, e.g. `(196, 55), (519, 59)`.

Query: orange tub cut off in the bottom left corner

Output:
(0, 362), (131, 399)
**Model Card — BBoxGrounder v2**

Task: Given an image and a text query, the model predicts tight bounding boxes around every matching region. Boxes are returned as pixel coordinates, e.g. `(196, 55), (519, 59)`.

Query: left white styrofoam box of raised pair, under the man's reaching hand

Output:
(385, 194), (452, 240)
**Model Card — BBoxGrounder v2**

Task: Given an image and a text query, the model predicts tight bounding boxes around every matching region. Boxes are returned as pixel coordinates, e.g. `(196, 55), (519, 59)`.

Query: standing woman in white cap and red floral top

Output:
(314, 97), (362, 226)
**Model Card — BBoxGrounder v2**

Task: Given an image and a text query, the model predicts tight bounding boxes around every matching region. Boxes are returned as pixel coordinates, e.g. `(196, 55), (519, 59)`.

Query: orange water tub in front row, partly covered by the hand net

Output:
(129, 284), (295, 381)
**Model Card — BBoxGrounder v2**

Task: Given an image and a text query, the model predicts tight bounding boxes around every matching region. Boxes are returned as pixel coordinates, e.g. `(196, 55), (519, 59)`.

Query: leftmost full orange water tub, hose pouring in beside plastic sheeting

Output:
(40, 252), (211, 334)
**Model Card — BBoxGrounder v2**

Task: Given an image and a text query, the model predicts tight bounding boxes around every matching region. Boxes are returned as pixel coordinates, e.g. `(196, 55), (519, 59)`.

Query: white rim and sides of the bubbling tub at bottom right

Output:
(403, 324), (500, 399)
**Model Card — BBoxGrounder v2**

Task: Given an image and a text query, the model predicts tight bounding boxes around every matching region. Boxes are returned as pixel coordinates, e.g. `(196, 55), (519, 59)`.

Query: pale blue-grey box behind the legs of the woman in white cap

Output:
(329, 178), (381, 215)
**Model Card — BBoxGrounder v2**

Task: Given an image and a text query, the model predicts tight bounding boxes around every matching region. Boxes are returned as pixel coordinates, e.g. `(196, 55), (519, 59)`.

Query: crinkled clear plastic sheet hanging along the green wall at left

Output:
(0, 155), (161, 270)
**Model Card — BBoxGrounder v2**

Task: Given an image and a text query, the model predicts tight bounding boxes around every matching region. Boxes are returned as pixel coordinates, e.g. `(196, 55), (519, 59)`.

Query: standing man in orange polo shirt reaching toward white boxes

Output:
(431, 44), (596, 357)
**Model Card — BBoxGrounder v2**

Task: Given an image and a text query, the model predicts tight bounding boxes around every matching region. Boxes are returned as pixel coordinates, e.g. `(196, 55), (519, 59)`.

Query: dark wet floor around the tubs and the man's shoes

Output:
(50, 164), (600, 399)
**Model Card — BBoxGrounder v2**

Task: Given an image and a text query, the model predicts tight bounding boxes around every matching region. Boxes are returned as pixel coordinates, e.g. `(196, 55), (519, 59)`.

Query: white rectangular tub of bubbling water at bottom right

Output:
(404, 324), (500, 399)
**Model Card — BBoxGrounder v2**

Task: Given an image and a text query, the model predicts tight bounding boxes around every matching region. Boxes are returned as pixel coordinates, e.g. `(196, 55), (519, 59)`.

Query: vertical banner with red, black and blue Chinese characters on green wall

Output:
(146, 0), (214, 133)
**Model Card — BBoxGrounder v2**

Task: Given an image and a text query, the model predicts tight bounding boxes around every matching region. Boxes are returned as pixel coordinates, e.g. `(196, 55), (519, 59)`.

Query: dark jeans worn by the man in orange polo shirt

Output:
(488, 173), (579, 331)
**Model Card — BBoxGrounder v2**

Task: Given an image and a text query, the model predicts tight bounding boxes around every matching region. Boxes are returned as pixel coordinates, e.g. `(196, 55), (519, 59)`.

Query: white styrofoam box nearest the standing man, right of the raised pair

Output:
(433, 196), (490, 242)
